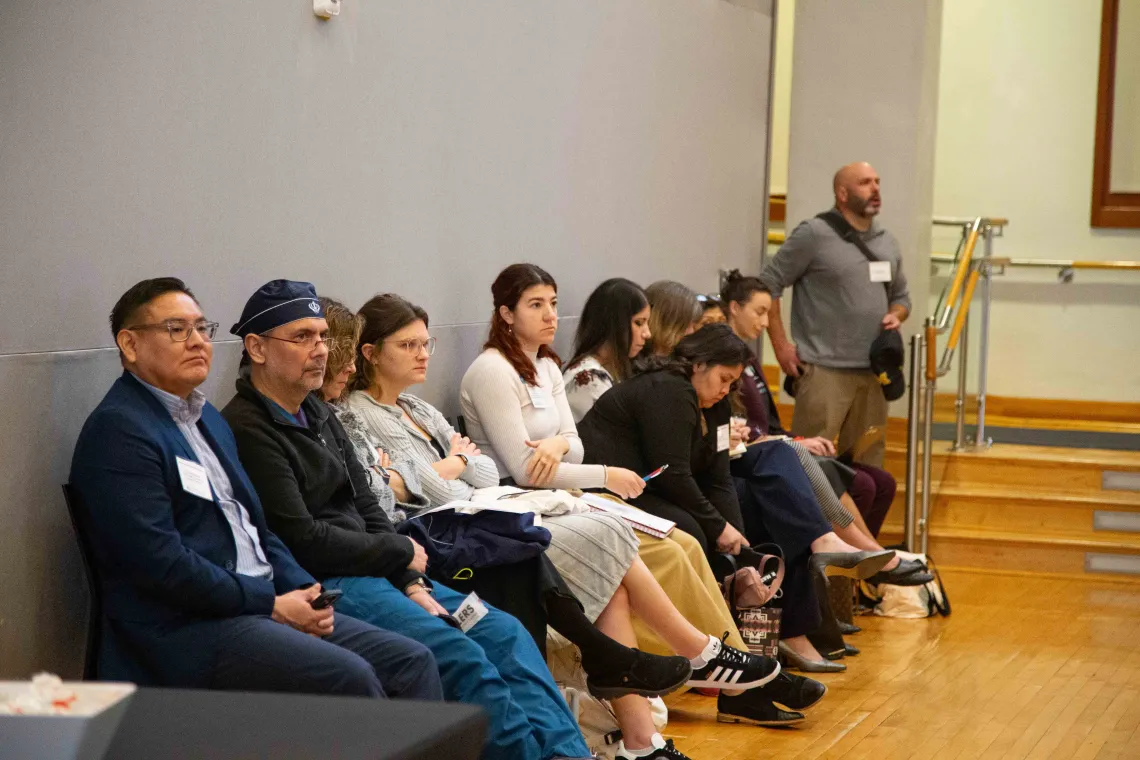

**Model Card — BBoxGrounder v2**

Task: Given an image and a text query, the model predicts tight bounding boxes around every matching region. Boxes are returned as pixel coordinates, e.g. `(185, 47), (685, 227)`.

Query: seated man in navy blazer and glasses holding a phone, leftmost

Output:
(71, 278), (441, 700)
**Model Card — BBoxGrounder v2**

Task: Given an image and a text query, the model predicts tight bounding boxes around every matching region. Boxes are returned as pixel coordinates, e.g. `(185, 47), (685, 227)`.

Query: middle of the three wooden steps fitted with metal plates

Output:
(888, 483), (1140, 550)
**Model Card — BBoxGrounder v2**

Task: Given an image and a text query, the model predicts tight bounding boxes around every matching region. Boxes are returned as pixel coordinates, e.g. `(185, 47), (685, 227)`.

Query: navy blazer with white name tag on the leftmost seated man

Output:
(71, 373), (315, 687)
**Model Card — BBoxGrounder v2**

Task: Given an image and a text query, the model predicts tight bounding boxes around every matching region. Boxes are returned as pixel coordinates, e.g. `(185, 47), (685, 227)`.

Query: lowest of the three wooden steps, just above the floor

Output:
(880, 525), (1140, 583)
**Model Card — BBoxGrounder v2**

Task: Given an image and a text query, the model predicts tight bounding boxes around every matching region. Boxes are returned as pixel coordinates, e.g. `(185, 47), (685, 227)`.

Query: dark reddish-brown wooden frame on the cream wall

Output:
(1091, 0), (1140, 228)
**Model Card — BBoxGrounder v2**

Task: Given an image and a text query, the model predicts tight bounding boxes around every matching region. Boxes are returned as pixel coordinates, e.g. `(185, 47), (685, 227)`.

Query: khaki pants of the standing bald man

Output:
(791, 365), (887, 467)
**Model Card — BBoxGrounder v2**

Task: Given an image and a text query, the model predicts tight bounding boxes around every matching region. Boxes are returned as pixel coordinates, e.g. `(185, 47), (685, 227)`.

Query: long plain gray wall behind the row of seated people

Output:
(0, 0), (772, 677)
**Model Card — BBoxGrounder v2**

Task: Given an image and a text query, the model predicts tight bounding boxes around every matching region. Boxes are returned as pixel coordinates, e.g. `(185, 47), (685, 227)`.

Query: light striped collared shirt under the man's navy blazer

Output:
(136, 375), (274, 579)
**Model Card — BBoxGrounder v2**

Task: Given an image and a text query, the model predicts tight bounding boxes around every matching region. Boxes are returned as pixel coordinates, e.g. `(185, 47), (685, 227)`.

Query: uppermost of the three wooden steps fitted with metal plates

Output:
(885, 441), (1140, 492)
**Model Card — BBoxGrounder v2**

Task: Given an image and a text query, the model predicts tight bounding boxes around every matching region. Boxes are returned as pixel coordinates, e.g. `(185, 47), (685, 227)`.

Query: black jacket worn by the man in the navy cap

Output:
(221, 377), (421, 589)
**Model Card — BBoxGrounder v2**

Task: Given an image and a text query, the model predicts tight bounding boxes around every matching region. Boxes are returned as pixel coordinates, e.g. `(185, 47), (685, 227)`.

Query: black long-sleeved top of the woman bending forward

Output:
(578, 369), (744, 544)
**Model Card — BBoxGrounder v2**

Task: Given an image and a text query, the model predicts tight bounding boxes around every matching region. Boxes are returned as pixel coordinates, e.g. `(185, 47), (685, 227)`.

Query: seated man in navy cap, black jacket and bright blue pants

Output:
(222, 280), (589, 760)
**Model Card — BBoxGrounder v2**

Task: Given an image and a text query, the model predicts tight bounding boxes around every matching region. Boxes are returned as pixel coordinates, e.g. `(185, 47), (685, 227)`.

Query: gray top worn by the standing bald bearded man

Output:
(760, 218), (911, 369)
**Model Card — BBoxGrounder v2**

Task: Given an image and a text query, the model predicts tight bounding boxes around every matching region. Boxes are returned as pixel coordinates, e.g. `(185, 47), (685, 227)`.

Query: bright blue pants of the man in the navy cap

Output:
(324, 578), (589, 760)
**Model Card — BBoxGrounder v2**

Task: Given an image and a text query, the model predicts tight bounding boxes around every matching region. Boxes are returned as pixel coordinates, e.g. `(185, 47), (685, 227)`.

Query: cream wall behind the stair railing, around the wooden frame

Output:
(934, 0), (1140, 401)
